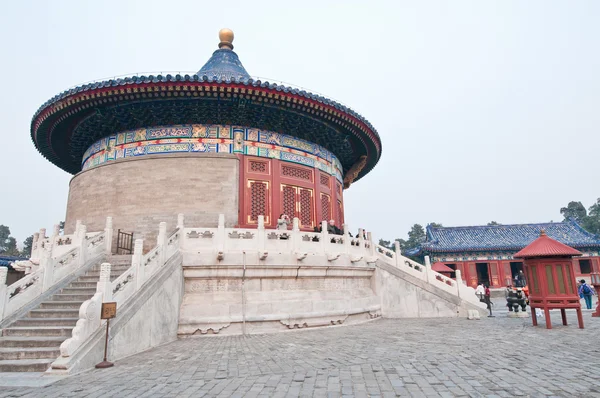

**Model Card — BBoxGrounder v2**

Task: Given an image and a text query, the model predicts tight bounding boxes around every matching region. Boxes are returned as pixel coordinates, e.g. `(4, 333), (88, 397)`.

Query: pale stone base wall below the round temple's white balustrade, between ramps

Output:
(178, 265), (381, 337)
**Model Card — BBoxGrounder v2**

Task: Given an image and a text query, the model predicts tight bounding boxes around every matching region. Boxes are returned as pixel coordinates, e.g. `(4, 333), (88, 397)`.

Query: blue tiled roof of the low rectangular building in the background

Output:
(407, 221), (600, 255)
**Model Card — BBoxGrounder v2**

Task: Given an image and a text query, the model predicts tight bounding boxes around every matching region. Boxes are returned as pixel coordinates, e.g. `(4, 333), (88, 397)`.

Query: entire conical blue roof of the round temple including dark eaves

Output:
(31, 30), (381, 180)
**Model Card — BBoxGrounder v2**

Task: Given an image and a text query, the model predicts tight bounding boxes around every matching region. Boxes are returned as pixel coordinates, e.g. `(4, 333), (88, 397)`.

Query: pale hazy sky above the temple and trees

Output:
(0, 0), (600, 242)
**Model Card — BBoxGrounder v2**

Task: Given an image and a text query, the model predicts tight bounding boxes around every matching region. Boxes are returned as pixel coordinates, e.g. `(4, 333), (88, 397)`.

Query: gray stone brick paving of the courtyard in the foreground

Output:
(0, 312), (600, 398)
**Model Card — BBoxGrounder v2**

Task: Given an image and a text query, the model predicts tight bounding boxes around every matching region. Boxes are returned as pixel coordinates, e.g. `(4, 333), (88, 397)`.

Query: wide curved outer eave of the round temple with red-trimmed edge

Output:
(31, 75), (381, 180)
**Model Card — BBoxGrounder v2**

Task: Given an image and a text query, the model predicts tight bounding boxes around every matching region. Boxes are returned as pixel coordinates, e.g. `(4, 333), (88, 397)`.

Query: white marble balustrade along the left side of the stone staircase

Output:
(0, 217), (112, 324)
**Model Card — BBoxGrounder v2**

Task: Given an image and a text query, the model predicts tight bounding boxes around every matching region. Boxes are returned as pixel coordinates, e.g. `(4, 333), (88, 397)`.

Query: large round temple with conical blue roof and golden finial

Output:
(31, 29), (381, 248)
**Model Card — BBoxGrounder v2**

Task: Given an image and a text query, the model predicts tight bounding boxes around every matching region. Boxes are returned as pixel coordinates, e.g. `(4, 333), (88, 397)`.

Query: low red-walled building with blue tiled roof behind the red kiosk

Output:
(407, 221), (600, 288)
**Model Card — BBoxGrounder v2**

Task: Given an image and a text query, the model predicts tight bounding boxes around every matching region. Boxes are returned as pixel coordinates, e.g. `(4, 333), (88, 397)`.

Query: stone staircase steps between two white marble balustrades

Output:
(0, 256), (131, 372)
